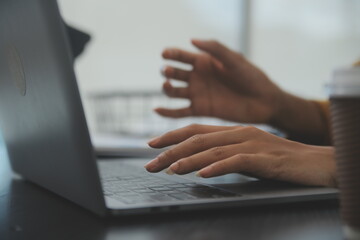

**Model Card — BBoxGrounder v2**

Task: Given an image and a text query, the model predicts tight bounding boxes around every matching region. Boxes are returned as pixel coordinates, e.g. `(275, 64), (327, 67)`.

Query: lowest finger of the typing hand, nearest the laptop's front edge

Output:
(196, 154), (258, 178)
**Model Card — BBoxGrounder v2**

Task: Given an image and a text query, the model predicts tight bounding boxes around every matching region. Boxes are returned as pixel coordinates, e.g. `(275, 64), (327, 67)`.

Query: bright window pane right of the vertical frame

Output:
(249, 0), (360, 99)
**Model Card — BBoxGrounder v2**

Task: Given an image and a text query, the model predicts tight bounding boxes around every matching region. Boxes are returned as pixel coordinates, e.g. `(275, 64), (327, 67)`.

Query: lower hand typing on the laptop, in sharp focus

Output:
(145, 125), (336, 187)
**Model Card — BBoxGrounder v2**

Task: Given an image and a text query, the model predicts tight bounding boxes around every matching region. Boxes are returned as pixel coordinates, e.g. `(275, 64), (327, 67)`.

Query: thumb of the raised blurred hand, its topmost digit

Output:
(191, 39), (235, 67)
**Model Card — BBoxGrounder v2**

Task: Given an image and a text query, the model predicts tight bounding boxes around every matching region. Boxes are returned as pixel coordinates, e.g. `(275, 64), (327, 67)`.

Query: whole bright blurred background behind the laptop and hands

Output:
(59, 0), (360, 139)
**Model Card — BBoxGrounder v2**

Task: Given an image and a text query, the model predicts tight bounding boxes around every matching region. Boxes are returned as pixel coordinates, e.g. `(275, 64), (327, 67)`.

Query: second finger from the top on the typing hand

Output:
(147, 126), (243, 172)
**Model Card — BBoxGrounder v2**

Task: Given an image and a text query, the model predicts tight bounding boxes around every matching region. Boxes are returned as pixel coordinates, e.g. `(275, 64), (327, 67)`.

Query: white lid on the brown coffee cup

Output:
(327, 67), (360, 97)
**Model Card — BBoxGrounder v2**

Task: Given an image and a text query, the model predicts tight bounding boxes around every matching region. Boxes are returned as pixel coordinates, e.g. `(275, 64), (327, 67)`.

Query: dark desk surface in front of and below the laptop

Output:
(0, 155), (342, 240)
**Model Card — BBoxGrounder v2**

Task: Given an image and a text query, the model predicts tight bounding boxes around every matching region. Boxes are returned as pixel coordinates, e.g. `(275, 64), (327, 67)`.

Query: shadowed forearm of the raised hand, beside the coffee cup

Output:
(271, 93), (331, 145)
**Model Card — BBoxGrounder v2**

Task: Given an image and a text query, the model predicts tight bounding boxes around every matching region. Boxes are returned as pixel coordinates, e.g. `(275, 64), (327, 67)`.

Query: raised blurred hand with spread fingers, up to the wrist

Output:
(155, 40), (284, 123)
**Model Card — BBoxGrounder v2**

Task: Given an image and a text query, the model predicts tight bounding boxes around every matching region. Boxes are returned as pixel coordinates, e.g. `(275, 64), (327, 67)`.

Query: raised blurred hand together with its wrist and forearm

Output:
(155, 40), (328, 144)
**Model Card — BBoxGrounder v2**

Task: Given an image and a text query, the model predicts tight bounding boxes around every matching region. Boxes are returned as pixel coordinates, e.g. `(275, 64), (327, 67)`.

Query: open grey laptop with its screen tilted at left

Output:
(0, 0), (337, 216)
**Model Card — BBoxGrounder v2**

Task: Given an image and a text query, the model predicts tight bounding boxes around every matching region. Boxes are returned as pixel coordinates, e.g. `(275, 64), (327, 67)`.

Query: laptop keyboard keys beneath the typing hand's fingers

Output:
(101, 163), (239, 204)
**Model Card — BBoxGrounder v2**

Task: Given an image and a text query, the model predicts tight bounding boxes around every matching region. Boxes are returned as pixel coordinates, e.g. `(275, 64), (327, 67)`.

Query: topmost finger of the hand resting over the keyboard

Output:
(148, 124), (236, 148)
